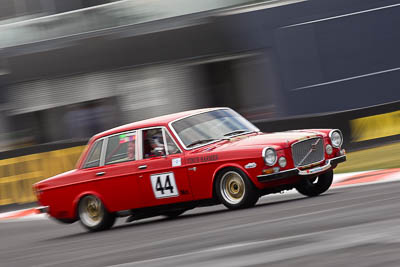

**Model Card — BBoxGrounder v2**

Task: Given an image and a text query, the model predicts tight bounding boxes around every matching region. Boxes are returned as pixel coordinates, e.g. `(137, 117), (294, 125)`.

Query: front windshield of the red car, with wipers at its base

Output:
(172, 109), (259, 148)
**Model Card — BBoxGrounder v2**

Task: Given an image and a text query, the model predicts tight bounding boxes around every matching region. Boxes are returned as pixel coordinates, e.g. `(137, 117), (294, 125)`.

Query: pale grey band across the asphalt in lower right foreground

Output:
(109, 219), (400, 267)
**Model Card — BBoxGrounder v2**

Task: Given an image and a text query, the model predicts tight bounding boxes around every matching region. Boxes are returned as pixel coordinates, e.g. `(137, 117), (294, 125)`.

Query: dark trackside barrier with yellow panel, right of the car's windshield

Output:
(254, 101), (400, 151)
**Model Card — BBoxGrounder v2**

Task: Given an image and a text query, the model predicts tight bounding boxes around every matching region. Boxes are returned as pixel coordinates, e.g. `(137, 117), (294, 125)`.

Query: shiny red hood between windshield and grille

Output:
(197, 130), (324, 154)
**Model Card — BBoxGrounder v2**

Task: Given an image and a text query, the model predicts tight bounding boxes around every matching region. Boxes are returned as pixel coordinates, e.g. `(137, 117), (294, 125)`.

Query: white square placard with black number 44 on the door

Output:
(150, 172), (179, 198)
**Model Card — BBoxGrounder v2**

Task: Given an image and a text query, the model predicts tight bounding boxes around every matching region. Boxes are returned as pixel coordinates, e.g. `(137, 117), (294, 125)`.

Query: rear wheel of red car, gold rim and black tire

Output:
(78, 195), (115, 232)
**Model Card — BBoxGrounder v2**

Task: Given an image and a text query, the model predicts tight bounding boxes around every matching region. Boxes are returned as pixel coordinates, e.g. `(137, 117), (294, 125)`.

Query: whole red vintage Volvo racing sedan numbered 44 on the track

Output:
(34, 108), (346, 231)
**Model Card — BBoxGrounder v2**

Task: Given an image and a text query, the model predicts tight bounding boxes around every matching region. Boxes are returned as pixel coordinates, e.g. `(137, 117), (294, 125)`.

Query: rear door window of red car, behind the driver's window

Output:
(104, 132), (136, 165)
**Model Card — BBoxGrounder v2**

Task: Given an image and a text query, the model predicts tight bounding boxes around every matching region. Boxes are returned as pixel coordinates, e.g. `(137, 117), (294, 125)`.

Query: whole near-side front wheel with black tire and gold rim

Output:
(214, 168), (260, 210)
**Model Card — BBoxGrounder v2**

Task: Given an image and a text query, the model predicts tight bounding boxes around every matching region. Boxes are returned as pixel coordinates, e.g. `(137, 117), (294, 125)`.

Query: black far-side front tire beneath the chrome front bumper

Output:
(296, 170), (333, 197)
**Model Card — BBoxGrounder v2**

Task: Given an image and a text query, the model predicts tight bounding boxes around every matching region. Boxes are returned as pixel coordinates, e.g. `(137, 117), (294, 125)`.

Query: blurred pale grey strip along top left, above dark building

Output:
(0, 0), (268, 49)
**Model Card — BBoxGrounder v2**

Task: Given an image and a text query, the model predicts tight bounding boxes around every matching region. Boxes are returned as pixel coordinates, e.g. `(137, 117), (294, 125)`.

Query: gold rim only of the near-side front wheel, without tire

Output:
(221, 171), (245, 204)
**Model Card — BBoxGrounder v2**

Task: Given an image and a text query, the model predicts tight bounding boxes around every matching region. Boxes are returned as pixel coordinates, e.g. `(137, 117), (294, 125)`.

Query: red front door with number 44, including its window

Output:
(136, 127), (193, 206)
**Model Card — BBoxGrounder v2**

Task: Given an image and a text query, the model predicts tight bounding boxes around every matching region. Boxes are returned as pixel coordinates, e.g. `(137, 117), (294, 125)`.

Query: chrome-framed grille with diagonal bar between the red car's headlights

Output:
(292, 138), (324, 167)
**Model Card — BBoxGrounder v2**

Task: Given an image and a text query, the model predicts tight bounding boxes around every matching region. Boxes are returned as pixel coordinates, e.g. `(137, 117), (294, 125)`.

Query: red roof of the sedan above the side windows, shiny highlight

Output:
(90, 108), (224, 143)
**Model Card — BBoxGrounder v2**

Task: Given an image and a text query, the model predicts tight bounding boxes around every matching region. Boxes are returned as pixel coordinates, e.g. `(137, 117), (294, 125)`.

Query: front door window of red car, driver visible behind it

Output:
(143, 128), (165, 159)
